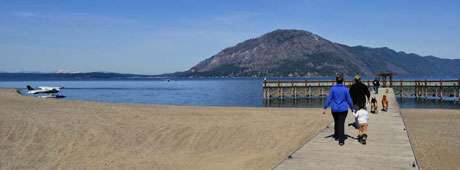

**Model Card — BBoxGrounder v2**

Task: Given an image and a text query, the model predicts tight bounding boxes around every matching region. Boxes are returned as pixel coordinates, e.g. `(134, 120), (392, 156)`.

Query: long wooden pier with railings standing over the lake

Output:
(263, 80), (460, 99)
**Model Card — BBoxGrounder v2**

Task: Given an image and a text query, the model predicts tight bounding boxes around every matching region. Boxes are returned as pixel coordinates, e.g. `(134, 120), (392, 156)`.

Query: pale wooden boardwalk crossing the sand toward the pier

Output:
(275, 88), (418, 170)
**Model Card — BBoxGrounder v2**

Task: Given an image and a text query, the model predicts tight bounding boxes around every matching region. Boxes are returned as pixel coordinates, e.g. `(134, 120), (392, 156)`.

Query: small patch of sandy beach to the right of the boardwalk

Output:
(401, 109), (460, 169)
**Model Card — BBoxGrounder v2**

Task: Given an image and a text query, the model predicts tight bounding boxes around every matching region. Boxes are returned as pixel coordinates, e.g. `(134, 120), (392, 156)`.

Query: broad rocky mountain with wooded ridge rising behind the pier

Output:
(175, 30), (460, 76)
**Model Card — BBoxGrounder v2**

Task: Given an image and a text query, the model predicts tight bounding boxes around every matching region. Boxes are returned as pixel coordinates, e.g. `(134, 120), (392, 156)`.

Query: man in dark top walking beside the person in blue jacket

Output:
(350, 74), (371, 110)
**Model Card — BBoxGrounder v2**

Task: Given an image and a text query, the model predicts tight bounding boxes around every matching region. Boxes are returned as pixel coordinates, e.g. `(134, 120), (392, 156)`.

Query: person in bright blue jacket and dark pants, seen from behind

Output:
(323, 74), (353, 146)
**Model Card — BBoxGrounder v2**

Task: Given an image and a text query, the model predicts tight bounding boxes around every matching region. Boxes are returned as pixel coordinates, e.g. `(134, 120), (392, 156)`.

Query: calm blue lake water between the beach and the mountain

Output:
(0, 79), (460, 109)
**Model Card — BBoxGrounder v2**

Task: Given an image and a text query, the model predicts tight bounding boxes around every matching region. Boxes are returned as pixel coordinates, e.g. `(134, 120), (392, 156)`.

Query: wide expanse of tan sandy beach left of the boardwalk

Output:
(0, 89), (331, 169)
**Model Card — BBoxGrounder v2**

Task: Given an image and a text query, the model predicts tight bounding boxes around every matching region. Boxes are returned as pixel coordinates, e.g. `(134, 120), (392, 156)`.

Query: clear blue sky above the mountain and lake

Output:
(0, 0), (460, 74)
